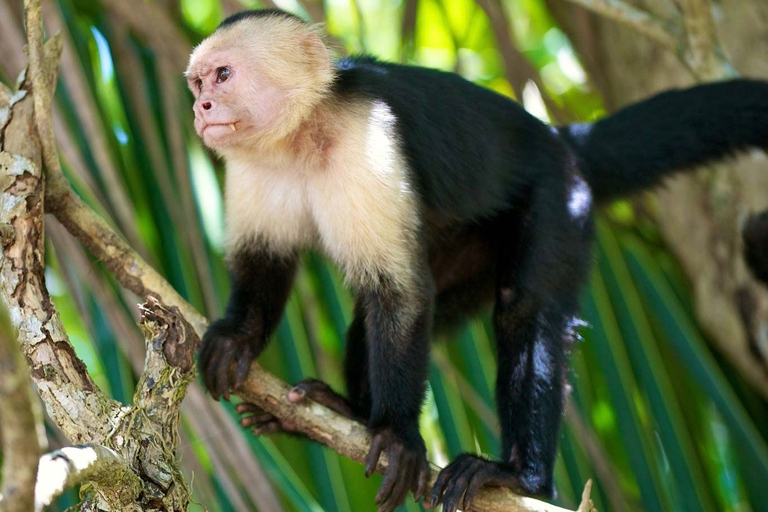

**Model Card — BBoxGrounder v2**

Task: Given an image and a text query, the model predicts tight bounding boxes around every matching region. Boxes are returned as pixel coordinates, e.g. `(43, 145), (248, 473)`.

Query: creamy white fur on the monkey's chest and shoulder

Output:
(226, 103), (418, 285)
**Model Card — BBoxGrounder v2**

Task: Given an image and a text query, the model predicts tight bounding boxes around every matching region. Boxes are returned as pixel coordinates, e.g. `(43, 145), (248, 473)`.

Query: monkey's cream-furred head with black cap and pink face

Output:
(184, 10), (333, 150)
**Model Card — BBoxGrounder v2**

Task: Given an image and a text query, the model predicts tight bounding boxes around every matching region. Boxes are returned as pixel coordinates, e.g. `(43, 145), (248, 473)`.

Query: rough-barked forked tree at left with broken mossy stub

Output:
(0, 2), (199, 511)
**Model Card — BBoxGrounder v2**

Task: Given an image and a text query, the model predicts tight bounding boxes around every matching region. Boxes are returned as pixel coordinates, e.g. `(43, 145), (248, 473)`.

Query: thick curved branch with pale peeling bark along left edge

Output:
(0, 48), (120, 443)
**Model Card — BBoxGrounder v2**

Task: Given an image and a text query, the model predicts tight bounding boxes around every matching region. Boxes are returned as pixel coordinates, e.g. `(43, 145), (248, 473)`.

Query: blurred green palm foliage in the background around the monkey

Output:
(0, 0), (768, 511)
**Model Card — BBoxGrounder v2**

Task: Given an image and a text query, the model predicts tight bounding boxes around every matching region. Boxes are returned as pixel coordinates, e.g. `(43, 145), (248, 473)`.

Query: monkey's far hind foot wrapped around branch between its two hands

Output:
(236, 379), (358, 436)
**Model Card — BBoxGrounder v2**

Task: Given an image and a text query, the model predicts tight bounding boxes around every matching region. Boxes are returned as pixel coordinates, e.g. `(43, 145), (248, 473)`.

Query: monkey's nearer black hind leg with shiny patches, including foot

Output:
(430, 167), (592, 512)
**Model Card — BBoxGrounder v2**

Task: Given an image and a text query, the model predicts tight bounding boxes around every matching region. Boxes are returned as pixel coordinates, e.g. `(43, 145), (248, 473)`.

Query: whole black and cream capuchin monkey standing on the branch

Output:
(186, 10), (768, 512)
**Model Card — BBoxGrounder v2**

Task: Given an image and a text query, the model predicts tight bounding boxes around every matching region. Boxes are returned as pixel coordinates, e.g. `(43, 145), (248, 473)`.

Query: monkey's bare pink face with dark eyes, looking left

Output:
(187, 52), (281, 149)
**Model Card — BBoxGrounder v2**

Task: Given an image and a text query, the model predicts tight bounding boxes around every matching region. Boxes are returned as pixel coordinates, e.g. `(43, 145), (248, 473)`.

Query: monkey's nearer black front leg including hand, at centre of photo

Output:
(362, 284), (433, 512)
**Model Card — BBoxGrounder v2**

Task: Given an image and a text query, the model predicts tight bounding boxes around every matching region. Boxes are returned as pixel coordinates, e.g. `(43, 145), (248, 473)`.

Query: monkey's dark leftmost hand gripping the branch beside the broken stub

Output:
(198, 317), (265, 400)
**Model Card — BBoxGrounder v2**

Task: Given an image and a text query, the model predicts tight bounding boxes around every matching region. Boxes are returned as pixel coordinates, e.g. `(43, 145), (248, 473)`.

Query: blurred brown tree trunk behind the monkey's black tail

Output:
(547, 0), (768, 399)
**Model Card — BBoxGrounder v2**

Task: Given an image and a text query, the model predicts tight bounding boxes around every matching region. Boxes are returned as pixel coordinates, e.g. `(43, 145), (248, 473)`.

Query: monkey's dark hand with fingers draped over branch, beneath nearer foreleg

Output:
(365, 429), (429, 512)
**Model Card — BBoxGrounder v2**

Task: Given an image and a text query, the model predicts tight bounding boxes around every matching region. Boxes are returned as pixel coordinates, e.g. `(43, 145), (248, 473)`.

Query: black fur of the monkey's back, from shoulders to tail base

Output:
(333, 56), (564, 220)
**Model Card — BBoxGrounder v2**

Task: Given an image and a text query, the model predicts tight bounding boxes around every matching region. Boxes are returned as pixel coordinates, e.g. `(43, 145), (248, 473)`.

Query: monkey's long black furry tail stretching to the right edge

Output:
(559, 80), (768, 202)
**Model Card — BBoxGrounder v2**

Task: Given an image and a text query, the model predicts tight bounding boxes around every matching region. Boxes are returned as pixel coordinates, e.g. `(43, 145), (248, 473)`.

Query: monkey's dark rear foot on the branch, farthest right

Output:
(429, 453), (527, 512)
